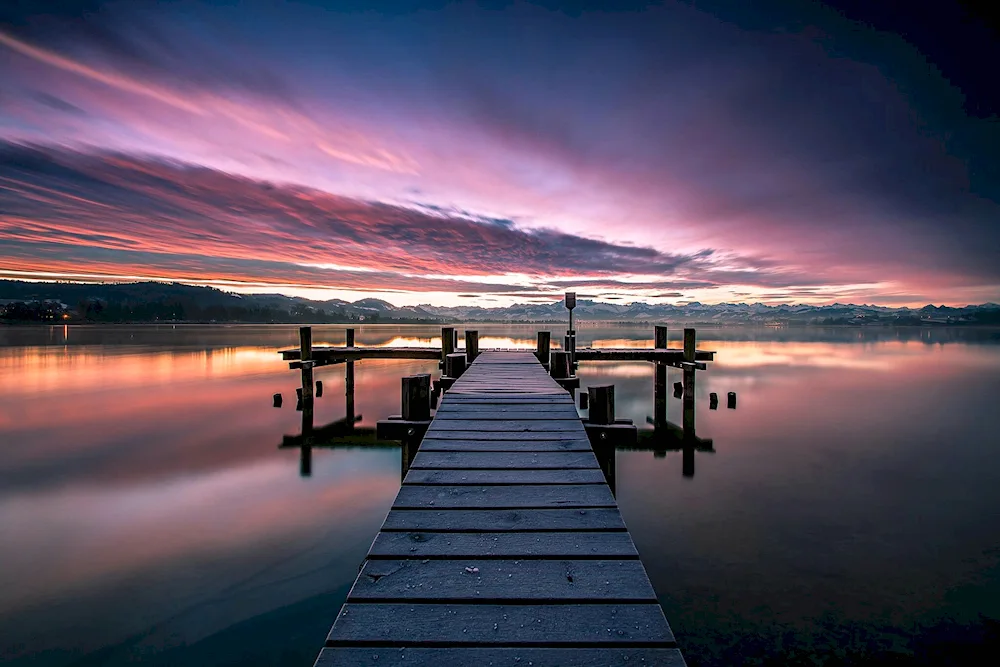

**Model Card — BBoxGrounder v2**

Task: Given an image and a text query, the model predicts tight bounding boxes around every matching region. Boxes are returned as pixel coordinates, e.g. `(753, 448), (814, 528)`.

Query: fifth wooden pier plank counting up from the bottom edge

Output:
(382, 508), (625, 533)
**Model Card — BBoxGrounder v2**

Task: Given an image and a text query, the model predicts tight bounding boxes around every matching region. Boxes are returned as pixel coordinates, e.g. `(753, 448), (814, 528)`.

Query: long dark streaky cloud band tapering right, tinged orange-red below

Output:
(0, 144), (780, 289)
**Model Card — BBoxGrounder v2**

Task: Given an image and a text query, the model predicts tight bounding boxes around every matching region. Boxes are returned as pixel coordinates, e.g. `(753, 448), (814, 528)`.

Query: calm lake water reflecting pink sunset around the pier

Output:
(0, 325), (1000, 667)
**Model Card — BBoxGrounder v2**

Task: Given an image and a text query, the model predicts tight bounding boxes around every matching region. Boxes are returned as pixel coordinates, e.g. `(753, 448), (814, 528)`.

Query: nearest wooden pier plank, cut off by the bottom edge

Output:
(314, 647), (685, 667)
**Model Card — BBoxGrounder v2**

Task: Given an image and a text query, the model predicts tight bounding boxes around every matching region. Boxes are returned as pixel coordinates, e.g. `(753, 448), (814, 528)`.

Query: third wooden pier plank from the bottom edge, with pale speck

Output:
(347, 559), (656, 602)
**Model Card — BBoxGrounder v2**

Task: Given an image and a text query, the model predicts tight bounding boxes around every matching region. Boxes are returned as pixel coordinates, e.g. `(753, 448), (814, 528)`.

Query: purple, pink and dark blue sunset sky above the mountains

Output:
(0, 0), (1000, 306)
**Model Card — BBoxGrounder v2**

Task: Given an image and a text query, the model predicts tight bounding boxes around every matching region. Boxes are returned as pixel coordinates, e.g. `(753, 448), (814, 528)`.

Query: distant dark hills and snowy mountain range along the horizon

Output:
(0, 280), (1000, 326)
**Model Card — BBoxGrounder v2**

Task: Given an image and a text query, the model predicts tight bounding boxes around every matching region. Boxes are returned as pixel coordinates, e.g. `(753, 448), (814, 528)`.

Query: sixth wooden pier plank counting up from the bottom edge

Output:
(392, 484), (616, 509)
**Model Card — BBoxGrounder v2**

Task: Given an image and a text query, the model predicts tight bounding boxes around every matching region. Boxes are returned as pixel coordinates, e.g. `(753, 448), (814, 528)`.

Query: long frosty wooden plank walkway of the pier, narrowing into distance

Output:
(316, 351), (684, 667)
